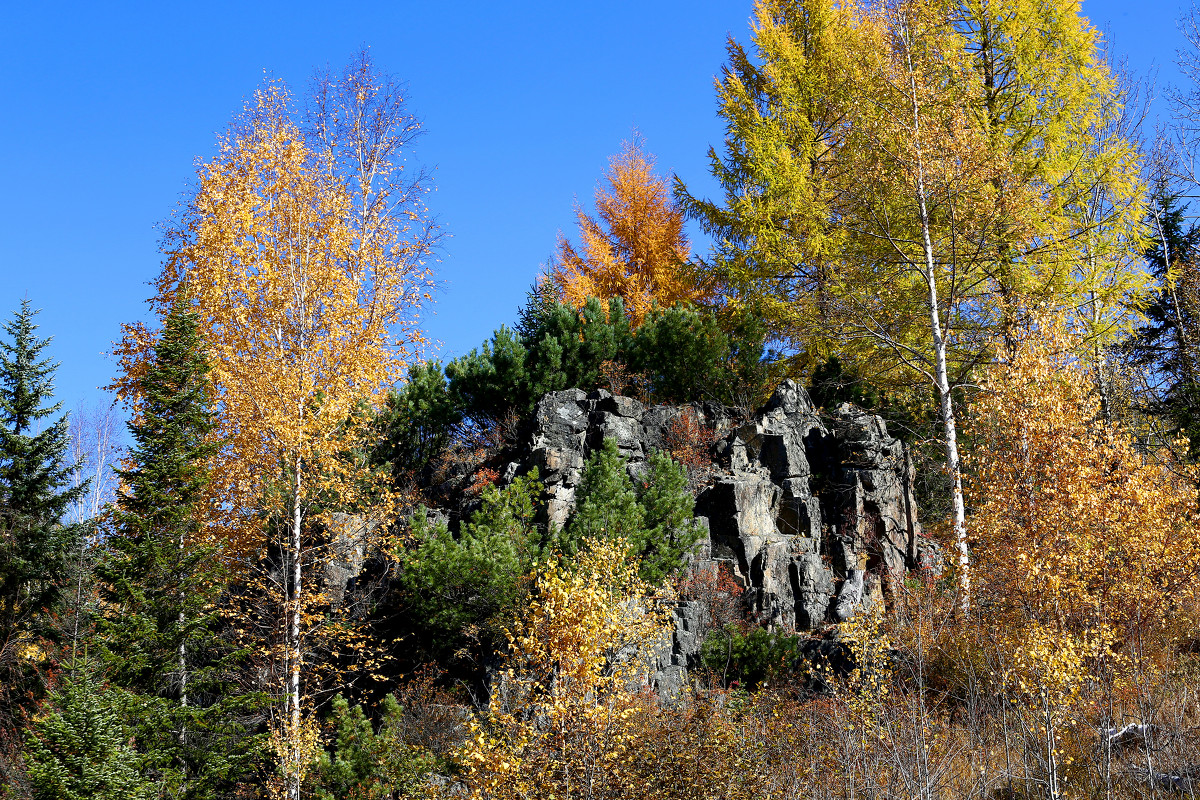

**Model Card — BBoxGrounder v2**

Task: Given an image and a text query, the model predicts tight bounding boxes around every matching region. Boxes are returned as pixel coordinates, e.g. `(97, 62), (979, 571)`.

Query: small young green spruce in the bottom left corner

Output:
(25, 661), (158, 800)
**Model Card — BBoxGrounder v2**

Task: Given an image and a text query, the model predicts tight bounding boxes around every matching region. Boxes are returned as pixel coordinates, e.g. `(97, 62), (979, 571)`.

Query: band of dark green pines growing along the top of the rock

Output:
(372, 289), (778, 486)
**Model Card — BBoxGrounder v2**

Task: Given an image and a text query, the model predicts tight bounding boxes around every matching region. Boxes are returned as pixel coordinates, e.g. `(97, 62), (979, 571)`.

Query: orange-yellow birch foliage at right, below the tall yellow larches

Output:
(970, 311), (1200, 652)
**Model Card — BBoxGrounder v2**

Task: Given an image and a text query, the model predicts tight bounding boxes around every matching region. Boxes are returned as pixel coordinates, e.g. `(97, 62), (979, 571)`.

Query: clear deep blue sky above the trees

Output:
(0, 0), (1182, 408)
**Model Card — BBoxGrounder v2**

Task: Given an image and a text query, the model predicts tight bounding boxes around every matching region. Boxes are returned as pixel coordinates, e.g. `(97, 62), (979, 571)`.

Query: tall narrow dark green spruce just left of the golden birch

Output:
(95, 307), (266, 798)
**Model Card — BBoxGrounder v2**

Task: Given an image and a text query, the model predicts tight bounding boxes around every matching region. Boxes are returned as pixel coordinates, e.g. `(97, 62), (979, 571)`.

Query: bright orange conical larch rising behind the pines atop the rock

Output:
(547, 139), (709, 325)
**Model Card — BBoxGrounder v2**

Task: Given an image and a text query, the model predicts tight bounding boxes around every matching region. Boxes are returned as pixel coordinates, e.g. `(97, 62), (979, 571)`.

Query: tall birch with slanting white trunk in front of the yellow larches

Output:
(835, 0), (1028, 607)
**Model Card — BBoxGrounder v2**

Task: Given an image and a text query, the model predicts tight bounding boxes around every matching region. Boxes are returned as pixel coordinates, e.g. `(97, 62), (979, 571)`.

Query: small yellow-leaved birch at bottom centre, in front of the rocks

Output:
(460, 541), (668, 800)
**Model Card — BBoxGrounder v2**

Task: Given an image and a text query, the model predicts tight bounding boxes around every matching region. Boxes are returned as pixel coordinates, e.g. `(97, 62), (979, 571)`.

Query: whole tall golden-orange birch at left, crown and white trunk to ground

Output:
(113, 55), (436, 800)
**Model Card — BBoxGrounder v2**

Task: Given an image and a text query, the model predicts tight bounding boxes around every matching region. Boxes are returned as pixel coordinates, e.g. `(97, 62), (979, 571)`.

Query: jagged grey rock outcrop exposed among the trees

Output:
(504, 380), (941, 691)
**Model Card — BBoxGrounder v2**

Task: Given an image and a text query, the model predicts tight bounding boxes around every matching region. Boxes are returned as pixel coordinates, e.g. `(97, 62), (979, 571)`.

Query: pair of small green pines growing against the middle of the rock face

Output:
(563, 439), (703, 584)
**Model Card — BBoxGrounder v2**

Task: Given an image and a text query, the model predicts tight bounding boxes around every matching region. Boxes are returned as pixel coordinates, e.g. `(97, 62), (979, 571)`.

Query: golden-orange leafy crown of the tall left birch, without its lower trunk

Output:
(115, 85), (431, 548)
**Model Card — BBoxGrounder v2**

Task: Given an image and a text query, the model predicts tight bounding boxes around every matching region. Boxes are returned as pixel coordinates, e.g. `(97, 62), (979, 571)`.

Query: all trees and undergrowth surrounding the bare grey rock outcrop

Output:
(7, 0), (1200, 800)
